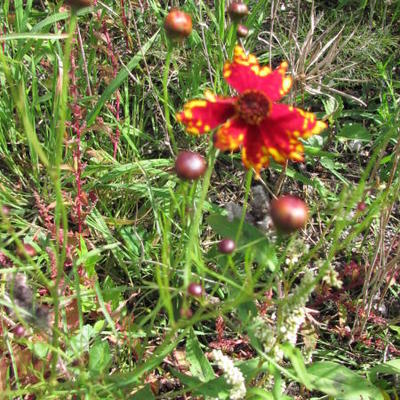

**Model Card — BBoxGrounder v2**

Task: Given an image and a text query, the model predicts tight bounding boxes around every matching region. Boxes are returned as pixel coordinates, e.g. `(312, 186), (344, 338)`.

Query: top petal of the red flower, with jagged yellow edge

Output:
(224, 46), (292, 101)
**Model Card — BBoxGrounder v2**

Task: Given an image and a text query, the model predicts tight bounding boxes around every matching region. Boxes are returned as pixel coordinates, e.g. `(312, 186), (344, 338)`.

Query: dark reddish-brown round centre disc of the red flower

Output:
(235, 90), (272, 125)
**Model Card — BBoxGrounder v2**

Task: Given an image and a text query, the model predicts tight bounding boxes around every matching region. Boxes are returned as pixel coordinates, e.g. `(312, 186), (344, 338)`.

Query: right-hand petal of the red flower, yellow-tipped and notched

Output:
(259, 104), (327, 163)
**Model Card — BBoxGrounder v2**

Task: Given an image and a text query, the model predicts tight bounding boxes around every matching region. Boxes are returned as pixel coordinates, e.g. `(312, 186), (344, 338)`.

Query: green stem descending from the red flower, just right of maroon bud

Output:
(183, 141), (218, 293)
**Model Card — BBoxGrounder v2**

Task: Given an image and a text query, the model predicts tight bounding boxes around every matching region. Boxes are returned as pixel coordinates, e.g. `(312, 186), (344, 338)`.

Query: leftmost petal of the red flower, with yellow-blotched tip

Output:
(176, 92), (235, 135)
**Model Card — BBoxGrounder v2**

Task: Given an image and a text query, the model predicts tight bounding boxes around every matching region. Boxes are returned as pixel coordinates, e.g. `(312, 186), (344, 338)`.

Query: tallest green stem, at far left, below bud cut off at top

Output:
(50, 8), (77, 379)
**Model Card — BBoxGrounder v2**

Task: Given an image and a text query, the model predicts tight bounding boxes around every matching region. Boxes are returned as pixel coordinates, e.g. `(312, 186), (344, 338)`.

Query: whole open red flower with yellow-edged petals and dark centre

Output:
(177, 46), (327, 174)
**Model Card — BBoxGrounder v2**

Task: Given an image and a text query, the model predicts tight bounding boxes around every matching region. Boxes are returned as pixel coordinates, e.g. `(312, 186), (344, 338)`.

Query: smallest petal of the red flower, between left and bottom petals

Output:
(214, 117), (248, 151)
